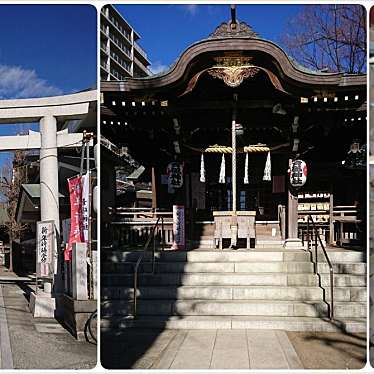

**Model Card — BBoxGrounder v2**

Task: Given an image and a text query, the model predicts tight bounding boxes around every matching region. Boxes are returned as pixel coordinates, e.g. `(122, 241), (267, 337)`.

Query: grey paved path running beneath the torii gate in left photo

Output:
(0, 273), (97, 369)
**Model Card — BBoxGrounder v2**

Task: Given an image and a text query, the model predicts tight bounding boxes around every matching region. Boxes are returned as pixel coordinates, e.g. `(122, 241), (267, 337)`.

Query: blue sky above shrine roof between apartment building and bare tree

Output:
(116, 4), (302, 72)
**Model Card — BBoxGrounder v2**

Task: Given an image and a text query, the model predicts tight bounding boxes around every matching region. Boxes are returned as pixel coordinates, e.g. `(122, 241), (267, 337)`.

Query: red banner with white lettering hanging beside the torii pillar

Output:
(64, 176), (84, 261)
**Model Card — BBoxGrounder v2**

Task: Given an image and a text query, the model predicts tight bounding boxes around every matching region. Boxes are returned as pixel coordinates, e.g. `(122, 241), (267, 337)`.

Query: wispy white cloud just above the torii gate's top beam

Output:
(0, 64), (63, 99)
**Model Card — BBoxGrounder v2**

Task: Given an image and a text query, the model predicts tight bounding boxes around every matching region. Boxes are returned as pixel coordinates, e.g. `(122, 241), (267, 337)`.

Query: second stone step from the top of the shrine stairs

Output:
(101, 261), (316, 274)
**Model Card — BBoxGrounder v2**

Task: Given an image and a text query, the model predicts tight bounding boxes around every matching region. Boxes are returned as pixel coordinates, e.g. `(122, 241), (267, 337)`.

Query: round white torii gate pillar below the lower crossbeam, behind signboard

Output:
(40, 116), (60, 292)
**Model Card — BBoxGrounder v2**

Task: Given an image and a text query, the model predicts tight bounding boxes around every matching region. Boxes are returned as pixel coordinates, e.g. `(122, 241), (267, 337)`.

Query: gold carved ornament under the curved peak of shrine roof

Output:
(207, 55), (260, 87)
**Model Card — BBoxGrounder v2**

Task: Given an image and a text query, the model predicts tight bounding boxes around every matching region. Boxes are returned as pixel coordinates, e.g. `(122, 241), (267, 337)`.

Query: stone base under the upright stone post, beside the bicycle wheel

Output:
(59, 294), (97, 340)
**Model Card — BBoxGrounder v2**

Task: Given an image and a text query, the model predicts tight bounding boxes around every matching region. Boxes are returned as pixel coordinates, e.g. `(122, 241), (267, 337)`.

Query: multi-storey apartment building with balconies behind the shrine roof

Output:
(100, 5), (152, 81)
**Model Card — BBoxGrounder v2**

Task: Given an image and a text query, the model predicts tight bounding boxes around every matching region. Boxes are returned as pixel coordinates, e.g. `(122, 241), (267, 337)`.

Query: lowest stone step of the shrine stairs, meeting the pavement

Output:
(100, 316), (366, 333)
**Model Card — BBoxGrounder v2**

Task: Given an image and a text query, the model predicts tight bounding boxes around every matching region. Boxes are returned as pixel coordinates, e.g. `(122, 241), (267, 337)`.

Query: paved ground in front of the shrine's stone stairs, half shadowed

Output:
(101, 329), (366, 369)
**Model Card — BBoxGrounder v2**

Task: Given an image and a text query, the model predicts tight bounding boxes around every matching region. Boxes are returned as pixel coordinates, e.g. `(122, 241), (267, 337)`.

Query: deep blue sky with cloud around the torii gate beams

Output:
(0, 4), (97, 166)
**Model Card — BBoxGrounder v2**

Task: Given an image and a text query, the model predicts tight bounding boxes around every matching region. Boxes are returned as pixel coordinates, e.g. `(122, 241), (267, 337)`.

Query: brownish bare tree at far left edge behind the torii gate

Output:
(0, 150), (28, 271)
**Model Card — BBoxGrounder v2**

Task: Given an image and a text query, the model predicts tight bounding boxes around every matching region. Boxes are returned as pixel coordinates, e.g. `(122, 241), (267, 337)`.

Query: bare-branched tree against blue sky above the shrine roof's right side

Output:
(280, 4), (367, 73)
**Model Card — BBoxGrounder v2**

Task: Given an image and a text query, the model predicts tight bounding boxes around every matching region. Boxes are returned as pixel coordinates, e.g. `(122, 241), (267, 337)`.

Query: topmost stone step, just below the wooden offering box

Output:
(102, 249), (311, 263)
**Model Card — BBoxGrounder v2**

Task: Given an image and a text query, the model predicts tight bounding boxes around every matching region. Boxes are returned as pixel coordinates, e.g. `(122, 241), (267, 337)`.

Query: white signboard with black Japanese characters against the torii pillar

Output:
(36, 221), (55, 277)
